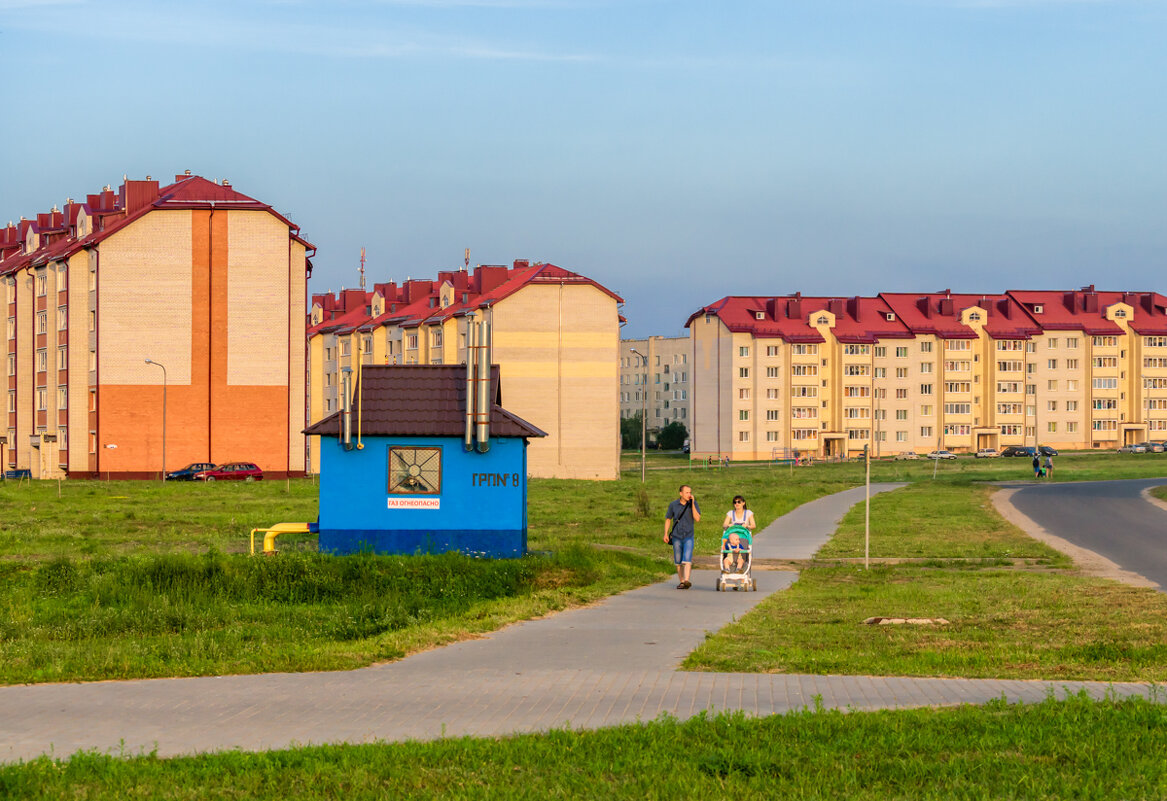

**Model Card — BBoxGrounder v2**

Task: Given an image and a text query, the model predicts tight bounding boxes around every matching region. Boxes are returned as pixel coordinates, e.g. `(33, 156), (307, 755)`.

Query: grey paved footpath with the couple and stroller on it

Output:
(0, 485), (1152, 761)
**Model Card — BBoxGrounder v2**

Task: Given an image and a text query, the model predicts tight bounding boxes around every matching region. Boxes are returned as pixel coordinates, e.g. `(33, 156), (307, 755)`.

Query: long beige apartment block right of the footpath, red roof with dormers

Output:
(686, 286), (1167, 459)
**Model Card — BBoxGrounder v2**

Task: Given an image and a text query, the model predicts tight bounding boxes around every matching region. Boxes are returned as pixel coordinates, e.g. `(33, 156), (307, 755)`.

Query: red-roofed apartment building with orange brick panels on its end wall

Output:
(0, 172), (314, 478)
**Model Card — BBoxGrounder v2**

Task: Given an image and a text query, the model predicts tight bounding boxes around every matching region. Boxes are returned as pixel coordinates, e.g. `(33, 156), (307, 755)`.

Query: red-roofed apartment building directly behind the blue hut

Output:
(308, 259), (622, 479)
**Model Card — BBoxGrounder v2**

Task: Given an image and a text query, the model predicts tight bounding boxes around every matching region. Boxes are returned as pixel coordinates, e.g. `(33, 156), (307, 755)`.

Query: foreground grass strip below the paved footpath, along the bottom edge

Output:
(0, 696), (1167, 801)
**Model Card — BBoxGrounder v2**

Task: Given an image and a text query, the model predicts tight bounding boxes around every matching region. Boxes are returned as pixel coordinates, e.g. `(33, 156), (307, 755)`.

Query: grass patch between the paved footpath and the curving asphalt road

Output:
(684, 474), (1167, 682)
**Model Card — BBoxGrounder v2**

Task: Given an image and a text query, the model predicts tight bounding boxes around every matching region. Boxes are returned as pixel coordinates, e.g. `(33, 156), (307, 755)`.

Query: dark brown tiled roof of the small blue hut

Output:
(303, 364), (547, 438)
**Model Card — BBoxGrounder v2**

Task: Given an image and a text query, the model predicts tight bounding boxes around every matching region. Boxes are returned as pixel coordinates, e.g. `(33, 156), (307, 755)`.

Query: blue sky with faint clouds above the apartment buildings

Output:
(0, 0), (1167, 336)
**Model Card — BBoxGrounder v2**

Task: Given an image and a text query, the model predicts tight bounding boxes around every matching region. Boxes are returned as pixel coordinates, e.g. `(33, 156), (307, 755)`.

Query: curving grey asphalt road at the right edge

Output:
(1011, 478), (1167, 591)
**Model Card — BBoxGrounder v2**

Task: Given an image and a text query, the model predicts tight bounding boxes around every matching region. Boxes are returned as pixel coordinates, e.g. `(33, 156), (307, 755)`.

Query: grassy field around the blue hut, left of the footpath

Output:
(0, 471), (847, 683)
